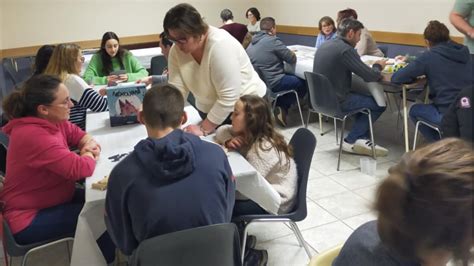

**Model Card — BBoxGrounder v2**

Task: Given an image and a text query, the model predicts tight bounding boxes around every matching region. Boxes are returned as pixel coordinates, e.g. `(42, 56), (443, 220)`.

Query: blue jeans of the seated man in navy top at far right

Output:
(410, 104), (443, 142)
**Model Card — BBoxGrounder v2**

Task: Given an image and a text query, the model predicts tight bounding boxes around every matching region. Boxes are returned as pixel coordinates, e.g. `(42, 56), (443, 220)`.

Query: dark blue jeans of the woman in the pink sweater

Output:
(14, 189), (115, 263)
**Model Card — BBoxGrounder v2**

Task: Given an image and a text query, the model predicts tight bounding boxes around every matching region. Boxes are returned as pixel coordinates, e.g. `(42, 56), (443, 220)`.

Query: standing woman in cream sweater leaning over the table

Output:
(163, 4), (266, 136)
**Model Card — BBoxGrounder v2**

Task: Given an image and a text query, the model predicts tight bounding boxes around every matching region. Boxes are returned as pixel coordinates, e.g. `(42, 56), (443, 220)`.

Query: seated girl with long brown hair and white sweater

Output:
(216, 95), (298, 216)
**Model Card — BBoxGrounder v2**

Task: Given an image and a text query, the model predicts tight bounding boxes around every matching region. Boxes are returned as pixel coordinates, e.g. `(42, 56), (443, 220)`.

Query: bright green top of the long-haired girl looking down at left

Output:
(84, 52), (148, 85)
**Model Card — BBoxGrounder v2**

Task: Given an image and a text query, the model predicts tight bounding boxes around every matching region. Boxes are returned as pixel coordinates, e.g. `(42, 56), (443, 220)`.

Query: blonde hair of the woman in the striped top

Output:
(44, 43), (81, 82)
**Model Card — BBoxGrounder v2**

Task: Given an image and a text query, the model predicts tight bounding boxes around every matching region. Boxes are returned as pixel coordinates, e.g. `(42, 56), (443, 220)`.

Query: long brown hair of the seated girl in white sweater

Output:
(239, 95), (293, 165)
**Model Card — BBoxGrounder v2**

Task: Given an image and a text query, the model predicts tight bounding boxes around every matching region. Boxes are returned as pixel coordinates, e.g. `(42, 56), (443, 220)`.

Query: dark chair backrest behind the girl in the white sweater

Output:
(289, 128), (316, 221)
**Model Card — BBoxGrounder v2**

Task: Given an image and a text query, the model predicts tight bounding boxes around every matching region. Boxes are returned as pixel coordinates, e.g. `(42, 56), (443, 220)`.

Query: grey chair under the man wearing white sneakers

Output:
(304, 71), (376, 171)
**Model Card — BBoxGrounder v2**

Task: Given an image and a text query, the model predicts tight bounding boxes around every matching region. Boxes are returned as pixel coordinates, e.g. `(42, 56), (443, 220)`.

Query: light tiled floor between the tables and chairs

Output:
(2, 101), (412, 266)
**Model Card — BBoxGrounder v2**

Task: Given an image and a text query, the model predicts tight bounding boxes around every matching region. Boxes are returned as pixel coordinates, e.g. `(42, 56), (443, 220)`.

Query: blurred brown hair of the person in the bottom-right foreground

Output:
(375, 138), (474, 265)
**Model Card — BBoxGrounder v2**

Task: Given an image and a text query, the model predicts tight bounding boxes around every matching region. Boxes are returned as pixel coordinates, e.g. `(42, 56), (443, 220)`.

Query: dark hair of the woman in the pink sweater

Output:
(3, 74), (61, 120)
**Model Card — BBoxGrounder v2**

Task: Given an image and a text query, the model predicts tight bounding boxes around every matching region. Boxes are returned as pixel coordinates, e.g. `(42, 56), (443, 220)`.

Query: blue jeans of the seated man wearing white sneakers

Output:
(341, 93), (386, 144)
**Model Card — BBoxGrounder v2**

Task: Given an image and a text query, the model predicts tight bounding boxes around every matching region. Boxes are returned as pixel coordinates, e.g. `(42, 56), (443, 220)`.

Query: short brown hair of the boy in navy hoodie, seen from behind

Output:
(143, 84), (184, 129)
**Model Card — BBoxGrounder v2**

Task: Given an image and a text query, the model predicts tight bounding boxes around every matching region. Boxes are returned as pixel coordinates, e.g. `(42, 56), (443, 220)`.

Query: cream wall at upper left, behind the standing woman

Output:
(0, 0), (252, 49)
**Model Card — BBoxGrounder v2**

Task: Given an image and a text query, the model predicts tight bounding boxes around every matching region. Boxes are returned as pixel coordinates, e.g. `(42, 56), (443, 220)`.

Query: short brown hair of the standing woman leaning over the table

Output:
(163, 4), (209, 36)
